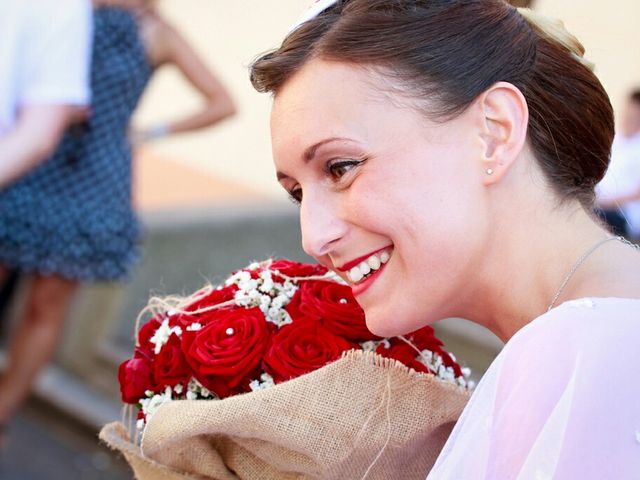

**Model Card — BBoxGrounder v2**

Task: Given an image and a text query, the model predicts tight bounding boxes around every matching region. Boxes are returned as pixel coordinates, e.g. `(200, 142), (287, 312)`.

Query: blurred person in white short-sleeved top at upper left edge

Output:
(0, 0), (92, 447)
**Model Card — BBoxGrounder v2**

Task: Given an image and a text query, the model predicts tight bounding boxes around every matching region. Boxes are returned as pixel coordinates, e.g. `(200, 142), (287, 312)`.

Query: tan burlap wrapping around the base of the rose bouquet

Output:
(101, 351), (469, 480)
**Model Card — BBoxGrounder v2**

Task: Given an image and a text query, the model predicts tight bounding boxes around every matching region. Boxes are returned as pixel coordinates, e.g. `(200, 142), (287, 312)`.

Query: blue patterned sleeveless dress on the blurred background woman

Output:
(0, 7), (152, 281)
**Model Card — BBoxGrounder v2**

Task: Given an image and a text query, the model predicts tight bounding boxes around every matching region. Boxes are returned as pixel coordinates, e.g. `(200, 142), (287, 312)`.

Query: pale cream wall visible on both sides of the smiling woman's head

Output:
(136, 0), (640, 199)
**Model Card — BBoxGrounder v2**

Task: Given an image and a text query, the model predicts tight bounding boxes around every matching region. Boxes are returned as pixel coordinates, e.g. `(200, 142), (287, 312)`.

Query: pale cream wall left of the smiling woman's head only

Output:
(135, 0), (310, 199)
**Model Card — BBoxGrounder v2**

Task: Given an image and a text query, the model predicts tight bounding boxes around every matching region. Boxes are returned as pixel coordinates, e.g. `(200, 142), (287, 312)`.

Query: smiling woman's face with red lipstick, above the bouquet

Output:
(271, 60), (488, 336)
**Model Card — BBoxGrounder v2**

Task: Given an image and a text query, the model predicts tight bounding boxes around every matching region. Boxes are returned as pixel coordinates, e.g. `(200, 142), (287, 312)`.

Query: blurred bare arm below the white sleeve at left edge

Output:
(0, 105), (78, 189)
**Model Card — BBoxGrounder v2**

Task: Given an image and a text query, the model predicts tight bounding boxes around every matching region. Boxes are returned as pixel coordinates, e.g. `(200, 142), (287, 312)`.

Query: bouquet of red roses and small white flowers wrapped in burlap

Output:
(101, 260), (470, 479)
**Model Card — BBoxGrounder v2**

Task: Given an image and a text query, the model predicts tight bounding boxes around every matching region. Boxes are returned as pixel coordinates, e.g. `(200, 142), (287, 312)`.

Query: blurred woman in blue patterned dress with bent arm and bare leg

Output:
(0, 0), (235, 446)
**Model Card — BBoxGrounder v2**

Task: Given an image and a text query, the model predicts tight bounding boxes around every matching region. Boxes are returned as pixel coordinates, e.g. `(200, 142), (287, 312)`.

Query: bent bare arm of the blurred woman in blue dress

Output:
(136, 13), (236, 139)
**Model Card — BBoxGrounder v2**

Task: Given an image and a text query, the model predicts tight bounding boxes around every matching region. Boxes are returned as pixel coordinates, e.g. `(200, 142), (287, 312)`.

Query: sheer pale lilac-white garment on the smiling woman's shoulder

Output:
(427, 298), (640, 480)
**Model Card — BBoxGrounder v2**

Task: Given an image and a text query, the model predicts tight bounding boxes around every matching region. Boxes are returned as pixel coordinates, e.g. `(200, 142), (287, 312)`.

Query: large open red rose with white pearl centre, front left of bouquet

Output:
(182, 308), (272, 398)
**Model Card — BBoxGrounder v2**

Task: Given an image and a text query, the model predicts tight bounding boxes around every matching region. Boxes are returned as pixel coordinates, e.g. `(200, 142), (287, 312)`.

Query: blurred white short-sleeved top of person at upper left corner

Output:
(0, 0), (93, 135)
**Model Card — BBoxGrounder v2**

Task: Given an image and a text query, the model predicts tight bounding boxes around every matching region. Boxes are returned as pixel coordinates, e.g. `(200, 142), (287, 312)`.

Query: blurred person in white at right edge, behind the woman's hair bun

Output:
(597, 89), (640, 240)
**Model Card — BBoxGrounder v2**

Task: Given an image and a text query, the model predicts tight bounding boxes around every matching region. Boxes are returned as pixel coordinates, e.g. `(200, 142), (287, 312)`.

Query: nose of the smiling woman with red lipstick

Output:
(300, 192), (347, 258)
